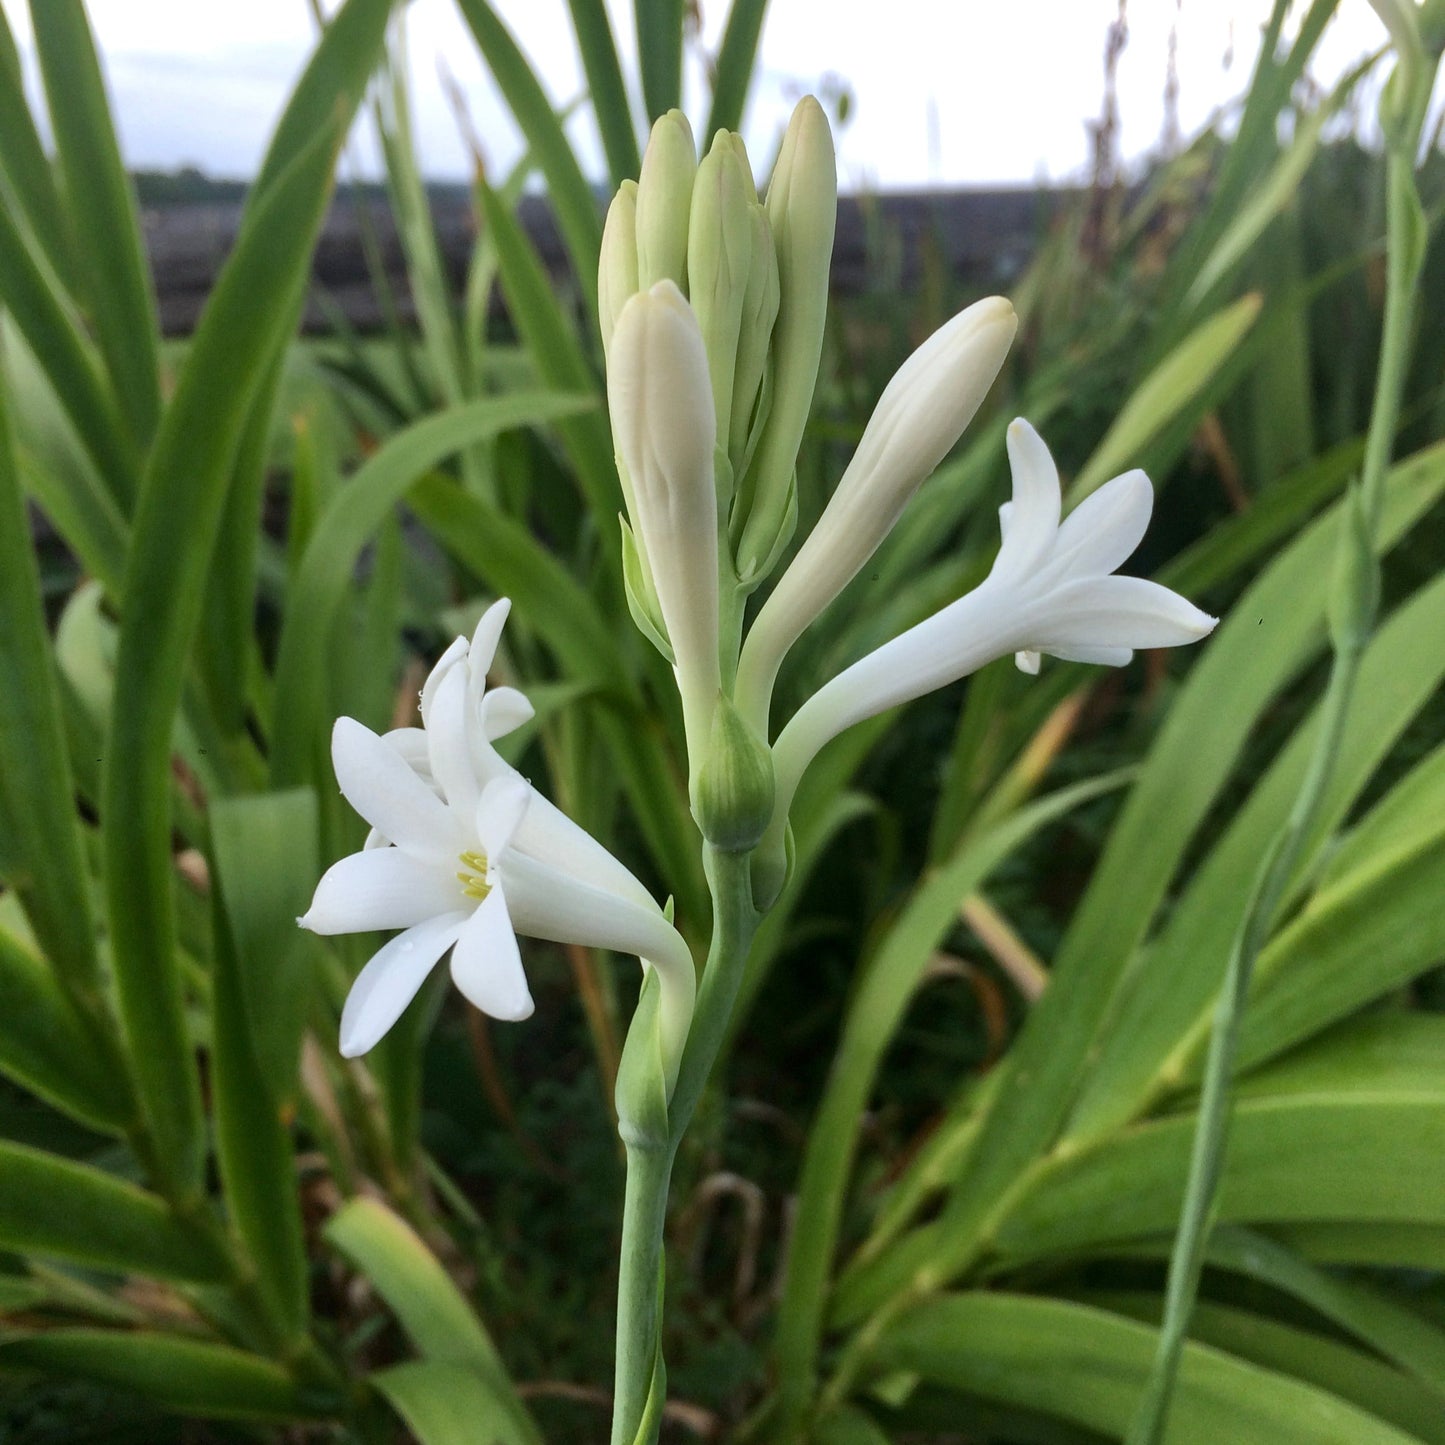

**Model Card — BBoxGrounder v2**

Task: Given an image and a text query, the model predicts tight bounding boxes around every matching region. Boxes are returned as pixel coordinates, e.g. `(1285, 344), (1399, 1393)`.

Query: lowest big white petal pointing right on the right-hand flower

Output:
(1029, 577), (1215, 653)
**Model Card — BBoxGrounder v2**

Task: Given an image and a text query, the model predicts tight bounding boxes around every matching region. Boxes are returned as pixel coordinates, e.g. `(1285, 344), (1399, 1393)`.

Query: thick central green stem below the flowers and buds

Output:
(611, 847), (759, 1445)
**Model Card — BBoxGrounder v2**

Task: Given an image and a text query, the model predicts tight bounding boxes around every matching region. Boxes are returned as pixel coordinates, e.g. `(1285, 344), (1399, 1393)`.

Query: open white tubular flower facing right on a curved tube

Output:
(763, 419), (1215, 893)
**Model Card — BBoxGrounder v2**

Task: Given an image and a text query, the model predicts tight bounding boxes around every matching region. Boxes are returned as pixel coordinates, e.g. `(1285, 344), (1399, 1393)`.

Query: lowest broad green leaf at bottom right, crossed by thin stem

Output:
(873, 1293), (1416, 1445)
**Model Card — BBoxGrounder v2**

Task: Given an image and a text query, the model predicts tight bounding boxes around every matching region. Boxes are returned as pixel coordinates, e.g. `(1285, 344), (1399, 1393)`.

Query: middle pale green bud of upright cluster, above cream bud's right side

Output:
(688, 130), (756, 447)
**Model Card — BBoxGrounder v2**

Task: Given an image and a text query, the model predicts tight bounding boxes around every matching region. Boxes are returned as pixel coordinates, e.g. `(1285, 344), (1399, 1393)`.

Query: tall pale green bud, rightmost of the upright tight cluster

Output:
(737, 95), (838, 574)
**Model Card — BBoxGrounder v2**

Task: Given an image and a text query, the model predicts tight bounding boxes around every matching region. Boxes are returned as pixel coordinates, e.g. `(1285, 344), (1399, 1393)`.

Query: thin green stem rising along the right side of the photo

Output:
(1127, 62), (1420, 1445)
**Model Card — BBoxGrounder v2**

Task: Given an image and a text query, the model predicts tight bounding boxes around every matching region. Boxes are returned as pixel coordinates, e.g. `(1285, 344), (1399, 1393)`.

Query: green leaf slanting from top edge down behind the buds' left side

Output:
(460, 0), (611, 313)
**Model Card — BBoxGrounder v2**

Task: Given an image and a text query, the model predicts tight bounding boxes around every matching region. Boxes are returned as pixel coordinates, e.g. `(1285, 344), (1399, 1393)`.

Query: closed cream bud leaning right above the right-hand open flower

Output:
(738, 296), (1019, 727)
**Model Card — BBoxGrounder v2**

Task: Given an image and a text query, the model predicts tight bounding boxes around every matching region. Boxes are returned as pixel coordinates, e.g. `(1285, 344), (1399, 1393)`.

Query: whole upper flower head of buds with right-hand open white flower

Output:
(598, 100), (1214, 907)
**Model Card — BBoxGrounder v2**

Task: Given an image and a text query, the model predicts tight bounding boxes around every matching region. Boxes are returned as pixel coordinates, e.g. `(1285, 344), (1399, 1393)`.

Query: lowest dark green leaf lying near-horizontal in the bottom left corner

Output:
(0, 1329), (317, 1420)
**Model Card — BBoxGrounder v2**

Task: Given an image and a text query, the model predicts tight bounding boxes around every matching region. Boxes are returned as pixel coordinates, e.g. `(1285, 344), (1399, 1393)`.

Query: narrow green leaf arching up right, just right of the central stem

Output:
(775, 777), (1120, 1427)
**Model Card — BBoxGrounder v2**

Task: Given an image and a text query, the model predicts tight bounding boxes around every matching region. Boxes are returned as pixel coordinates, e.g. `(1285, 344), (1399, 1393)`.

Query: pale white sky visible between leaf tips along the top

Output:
(3, 0), (1384, 189)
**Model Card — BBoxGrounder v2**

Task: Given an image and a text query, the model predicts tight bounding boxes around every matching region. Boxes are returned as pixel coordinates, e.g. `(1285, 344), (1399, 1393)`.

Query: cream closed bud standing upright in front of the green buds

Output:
(607, 280), (720, 767)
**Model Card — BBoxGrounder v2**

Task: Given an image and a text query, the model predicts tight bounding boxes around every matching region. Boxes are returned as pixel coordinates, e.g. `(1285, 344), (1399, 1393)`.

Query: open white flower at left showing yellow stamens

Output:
(298, 601), (695, 1088)
